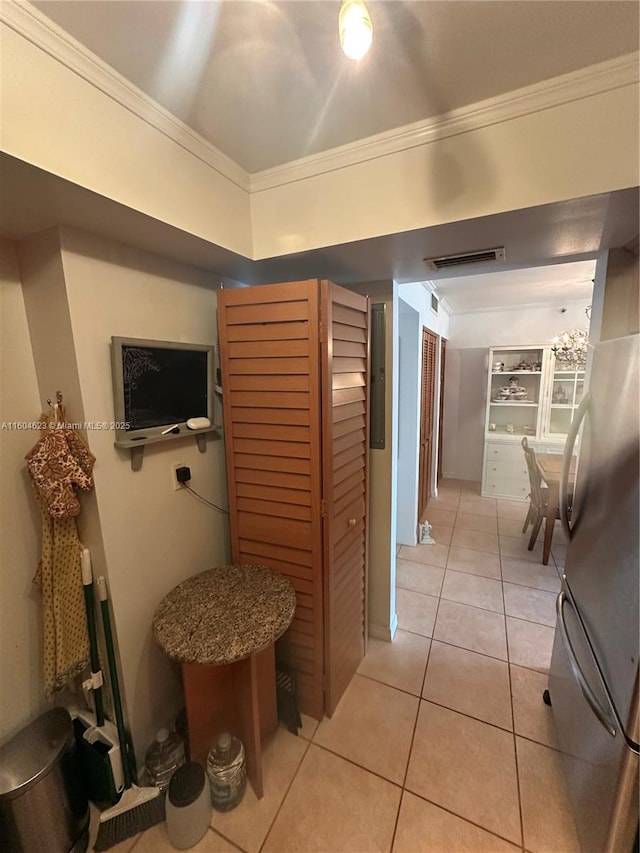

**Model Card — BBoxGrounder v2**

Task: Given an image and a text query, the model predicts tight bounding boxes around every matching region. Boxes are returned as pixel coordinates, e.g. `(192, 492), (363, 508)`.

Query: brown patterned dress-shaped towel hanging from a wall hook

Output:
(26, 420), (95, 696)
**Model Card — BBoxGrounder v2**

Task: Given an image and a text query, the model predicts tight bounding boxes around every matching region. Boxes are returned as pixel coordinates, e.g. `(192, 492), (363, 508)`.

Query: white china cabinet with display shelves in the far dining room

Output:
(482, 345), (564, 500)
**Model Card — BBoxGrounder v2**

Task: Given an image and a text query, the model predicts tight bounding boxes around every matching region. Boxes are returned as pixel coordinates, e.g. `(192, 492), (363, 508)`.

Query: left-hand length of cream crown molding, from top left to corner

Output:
(0, 0), (250, 192)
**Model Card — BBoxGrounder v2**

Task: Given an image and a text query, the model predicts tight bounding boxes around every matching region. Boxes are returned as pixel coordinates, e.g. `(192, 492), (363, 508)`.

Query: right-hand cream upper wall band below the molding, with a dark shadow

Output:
(251, 86), (638, 258)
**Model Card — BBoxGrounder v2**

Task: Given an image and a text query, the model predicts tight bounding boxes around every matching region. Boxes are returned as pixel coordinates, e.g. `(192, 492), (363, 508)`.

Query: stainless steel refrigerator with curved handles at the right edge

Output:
(549, 335), (640, 853)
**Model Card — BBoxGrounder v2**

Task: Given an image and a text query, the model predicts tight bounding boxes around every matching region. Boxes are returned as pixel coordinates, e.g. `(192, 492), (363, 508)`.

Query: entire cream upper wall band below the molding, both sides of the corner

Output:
(0, 14), (639, 259)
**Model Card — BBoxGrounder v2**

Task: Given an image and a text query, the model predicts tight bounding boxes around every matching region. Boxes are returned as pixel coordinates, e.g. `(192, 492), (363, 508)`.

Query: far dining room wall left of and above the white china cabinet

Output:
(443, 300), (589, 481)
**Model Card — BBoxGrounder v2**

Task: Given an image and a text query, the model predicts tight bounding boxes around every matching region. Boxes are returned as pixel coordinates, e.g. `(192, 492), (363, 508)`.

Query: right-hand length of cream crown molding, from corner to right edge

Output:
(251, 52), (640, 193)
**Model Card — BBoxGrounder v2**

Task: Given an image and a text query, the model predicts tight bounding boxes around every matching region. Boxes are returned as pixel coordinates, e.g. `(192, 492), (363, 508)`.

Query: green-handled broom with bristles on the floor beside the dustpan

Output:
(94, 577), (165, 853)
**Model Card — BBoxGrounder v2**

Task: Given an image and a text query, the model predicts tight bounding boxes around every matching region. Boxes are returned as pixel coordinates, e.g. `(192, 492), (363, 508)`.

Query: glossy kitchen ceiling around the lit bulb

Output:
(33, 0), (640, 172)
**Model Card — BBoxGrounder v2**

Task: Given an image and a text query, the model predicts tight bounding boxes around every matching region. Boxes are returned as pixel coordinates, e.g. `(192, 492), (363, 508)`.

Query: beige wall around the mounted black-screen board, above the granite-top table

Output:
(11, 228), (228, 758)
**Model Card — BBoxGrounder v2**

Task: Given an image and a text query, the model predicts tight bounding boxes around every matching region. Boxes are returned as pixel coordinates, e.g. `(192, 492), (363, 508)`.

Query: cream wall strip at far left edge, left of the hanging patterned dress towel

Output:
(0, 240), (48, 743)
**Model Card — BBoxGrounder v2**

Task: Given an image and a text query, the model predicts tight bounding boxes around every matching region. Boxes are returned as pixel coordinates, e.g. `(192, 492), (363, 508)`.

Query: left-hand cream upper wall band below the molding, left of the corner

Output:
(0, 24), (251, 256)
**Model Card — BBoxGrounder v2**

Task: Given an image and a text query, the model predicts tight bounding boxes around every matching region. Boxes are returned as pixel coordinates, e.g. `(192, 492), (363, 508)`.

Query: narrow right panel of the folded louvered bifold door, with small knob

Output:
(321, 281), (369, 716)
